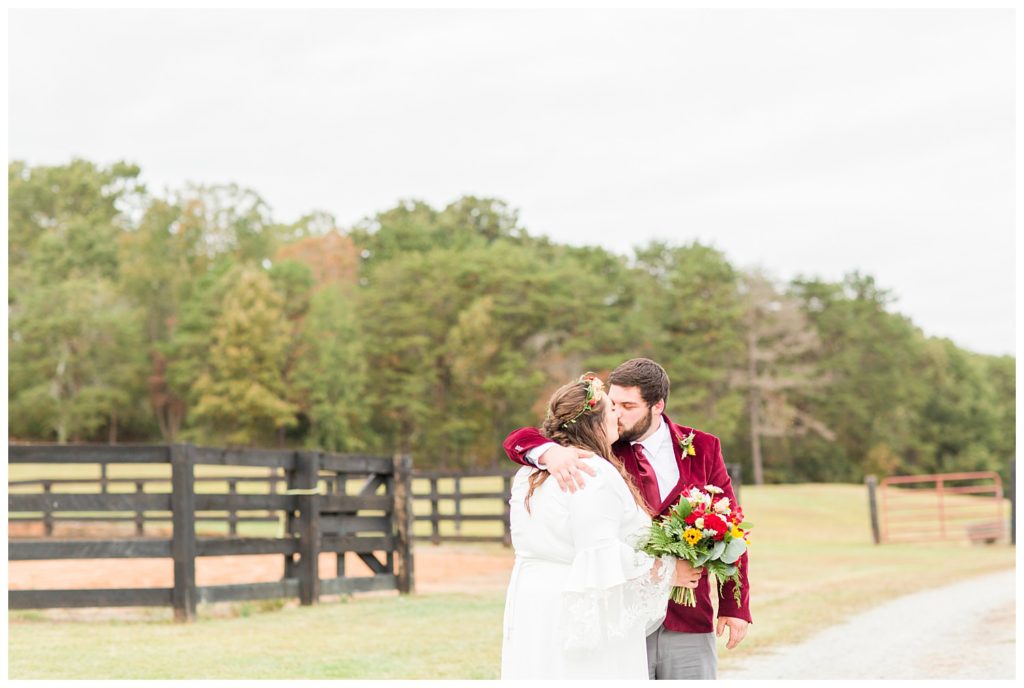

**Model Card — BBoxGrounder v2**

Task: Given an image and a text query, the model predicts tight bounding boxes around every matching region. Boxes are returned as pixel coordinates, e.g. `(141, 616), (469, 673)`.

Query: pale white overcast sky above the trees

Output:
(8, 9), (1015, 353)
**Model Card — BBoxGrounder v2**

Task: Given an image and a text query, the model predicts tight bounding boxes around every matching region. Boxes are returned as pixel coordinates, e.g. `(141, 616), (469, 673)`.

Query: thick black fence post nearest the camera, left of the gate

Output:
(171, 444), (196, 621)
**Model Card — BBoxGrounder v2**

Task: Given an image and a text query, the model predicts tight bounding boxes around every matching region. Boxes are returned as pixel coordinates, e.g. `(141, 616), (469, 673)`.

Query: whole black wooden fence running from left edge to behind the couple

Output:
(8, 444), (741, 620)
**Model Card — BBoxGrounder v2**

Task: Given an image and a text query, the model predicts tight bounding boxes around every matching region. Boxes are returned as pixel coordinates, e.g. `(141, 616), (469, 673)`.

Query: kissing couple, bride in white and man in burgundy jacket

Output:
(502, 358), (751, 679)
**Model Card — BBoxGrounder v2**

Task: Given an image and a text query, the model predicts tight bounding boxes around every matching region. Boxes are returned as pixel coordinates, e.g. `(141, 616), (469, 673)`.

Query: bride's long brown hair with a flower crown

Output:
(524, 376), (650, 516)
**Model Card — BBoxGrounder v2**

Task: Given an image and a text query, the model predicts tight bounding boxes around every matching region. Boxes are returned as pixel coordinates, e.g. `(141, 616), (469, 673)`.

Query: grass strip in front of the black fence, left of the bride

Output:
(8, 593), (504, 680)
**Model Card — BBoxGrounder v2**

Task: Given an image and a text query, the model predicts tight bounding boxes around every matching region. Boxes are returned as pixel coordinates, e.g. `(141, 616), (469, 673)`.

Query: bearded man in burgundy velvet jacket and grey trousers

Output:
(505, 358), (751, 679)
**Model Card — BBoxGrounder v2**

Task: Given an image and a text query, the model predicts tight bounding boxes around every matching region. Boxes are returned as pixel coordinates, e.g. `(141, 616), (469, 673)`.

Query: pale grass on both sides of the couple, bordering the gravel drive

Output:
(8, 484), (1015, 679)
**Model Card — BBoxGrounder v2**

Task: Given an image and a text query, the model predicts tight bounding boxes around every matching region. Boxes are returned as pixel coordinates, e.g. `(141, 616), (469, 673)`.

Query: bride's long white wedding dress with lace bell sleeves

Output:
(502, 458), (674, 679)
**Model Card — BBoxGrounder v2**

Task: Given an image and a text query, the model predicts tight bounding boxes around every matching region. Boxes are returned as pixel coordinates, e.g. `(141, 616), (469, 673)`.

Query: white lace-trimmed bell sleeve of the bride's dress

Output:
(562, 466), (675, 650)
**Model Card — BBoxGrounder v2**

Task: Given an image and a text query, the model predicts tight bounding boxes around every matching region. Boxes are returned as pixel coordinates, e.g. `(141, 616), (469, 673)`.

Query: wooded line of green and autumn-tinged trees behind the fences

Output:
(8, 160), (1015, 482)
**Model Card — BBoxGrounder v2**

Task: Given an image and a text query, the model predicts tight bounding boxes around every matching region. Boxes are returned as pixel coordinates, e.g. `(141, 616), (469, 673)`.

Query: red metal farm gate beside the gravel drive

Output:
(868, 471), (1007, 543)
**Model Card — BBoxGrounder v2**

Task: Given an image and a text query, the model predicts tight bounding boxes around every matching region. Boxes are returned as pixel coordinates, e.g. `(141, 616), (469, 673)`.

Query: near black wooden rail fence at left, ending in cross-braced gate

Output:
(7, 444), (414, 620)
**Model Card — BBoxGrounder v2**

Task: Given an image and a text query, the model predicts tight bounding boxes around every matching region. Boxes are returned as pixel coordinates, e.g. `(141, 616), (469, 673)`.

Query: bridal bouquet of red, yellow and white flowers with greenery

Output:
(639, 485), (753, 607)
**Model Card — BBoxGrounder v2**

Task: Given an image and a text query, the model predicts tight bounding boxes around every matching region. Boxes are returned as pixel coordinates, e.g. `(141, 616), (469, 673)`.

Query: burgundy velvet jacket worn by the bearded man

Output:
(504, 415), (751, 633)
